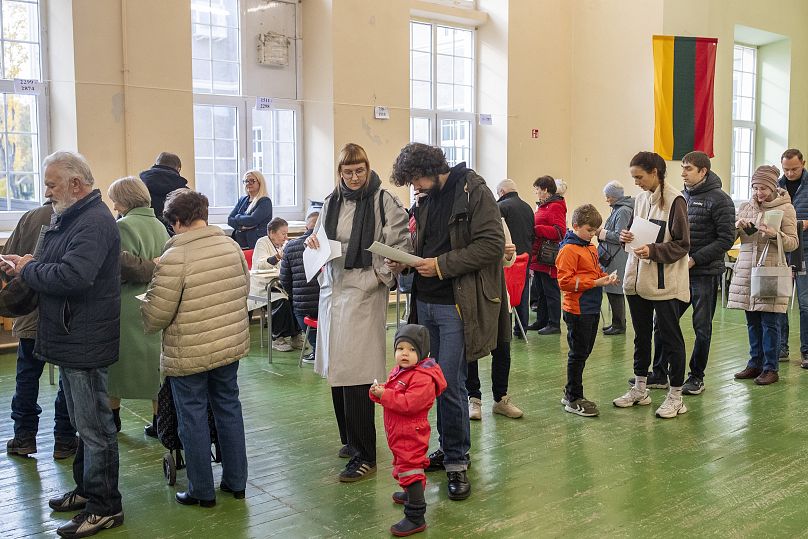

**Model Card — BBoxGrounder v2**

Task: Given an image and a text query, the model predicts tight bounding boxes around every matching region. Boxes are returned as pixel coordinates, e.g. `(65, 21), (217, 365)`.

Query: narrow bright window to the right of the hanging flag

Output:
(732, 44), (757, 200)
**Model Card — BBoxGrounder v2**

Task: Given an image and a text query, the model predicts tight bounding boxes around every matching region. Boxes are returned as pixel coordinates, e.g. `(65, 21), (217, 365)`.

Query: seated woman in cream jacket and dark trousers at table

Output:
(249, 217), (304, 352)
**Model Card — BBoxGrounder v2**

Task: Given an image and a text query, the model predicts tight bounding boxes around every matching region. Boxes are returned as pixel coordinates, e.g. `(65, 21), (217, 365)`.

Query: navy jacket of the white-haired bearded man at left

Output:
(21, 189), (121, 369)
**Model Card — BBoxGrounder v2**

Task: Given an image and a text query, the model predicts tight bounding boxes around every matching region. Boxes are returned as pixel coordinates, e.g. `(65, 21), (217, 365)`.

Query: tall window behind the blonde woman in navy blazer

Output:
(191, 0), (302, 222)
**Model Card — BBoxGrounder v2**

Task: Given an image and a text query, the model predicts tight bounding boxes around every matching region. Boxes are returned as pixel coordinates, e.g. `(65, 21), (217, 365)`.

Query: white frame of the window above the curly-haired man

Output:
(407, 17), (479, 168)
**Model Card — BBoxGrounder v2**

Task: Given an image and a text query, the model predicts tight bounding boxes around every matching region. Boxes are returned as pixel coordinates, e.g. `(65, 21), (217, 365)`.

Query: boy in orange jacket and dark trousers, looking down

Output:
(556, 204), (619, 417)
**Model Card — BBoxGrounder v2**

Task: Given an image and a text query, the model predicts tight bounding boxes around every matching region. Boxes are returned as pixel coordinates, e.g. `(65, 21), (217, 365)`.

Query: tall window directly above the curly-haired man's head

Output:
(410, 21), (475, 166)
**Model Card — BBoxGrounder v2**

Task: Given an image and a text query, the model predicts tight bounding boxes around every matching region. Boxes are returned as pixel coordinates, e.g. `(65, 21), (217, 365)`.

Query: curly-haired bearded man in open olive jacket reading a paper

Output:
(392, 143), (510, 500)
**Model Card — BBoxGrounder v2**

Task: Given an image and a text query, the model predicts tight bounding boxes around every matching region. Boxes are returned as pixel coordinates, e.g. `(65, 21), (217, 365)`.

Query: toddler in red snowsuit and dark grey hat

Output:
(370, 324), (446, 537)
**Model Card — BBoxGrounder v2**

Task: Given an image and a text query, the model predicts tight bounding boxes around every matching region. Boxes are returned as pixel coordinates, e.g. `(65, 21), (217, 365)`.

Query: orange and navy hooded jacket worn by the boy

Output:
(556, 230), (606, 314)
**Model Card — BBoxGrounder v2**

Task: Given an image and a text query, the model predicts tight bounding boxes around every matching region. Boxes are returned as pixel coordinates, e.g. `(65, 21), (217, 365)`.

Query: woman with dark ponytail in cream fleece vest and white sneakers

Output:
(613, 152), (690, 418)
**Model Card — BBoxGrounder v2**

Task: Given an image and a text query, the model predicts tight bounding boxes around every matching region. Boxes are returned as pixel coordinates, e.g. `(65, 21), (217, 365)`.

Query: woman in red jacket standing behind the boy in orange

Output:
(525, 176), (567, 335)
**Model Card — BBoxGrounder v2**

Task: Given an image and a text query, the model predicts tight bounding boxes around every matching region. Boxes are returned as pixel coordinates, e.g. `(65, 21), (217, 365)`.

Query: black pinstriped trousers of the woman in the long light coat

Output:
(331, 384), (376, 463)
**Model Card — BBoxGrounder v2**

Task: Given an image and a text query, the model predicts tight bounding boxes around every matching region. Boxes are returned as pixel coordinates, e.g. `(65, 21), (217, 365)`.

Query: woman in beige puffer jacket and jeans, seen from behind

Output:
(141, 189), (250, 507)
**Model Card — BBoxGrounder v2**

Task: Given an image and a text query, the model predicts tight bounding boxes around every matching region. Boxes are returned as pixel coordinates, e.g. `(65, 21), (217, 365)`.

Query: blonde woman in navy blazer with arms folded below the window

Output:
(227, 170), (272, 249)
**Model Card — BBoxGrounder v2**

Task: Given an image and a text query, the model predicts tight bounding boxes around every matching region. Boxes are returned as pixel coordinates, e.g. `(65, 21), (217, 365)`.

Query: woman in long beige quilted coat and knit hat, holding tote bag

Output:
(727, 165), (798, 385)
